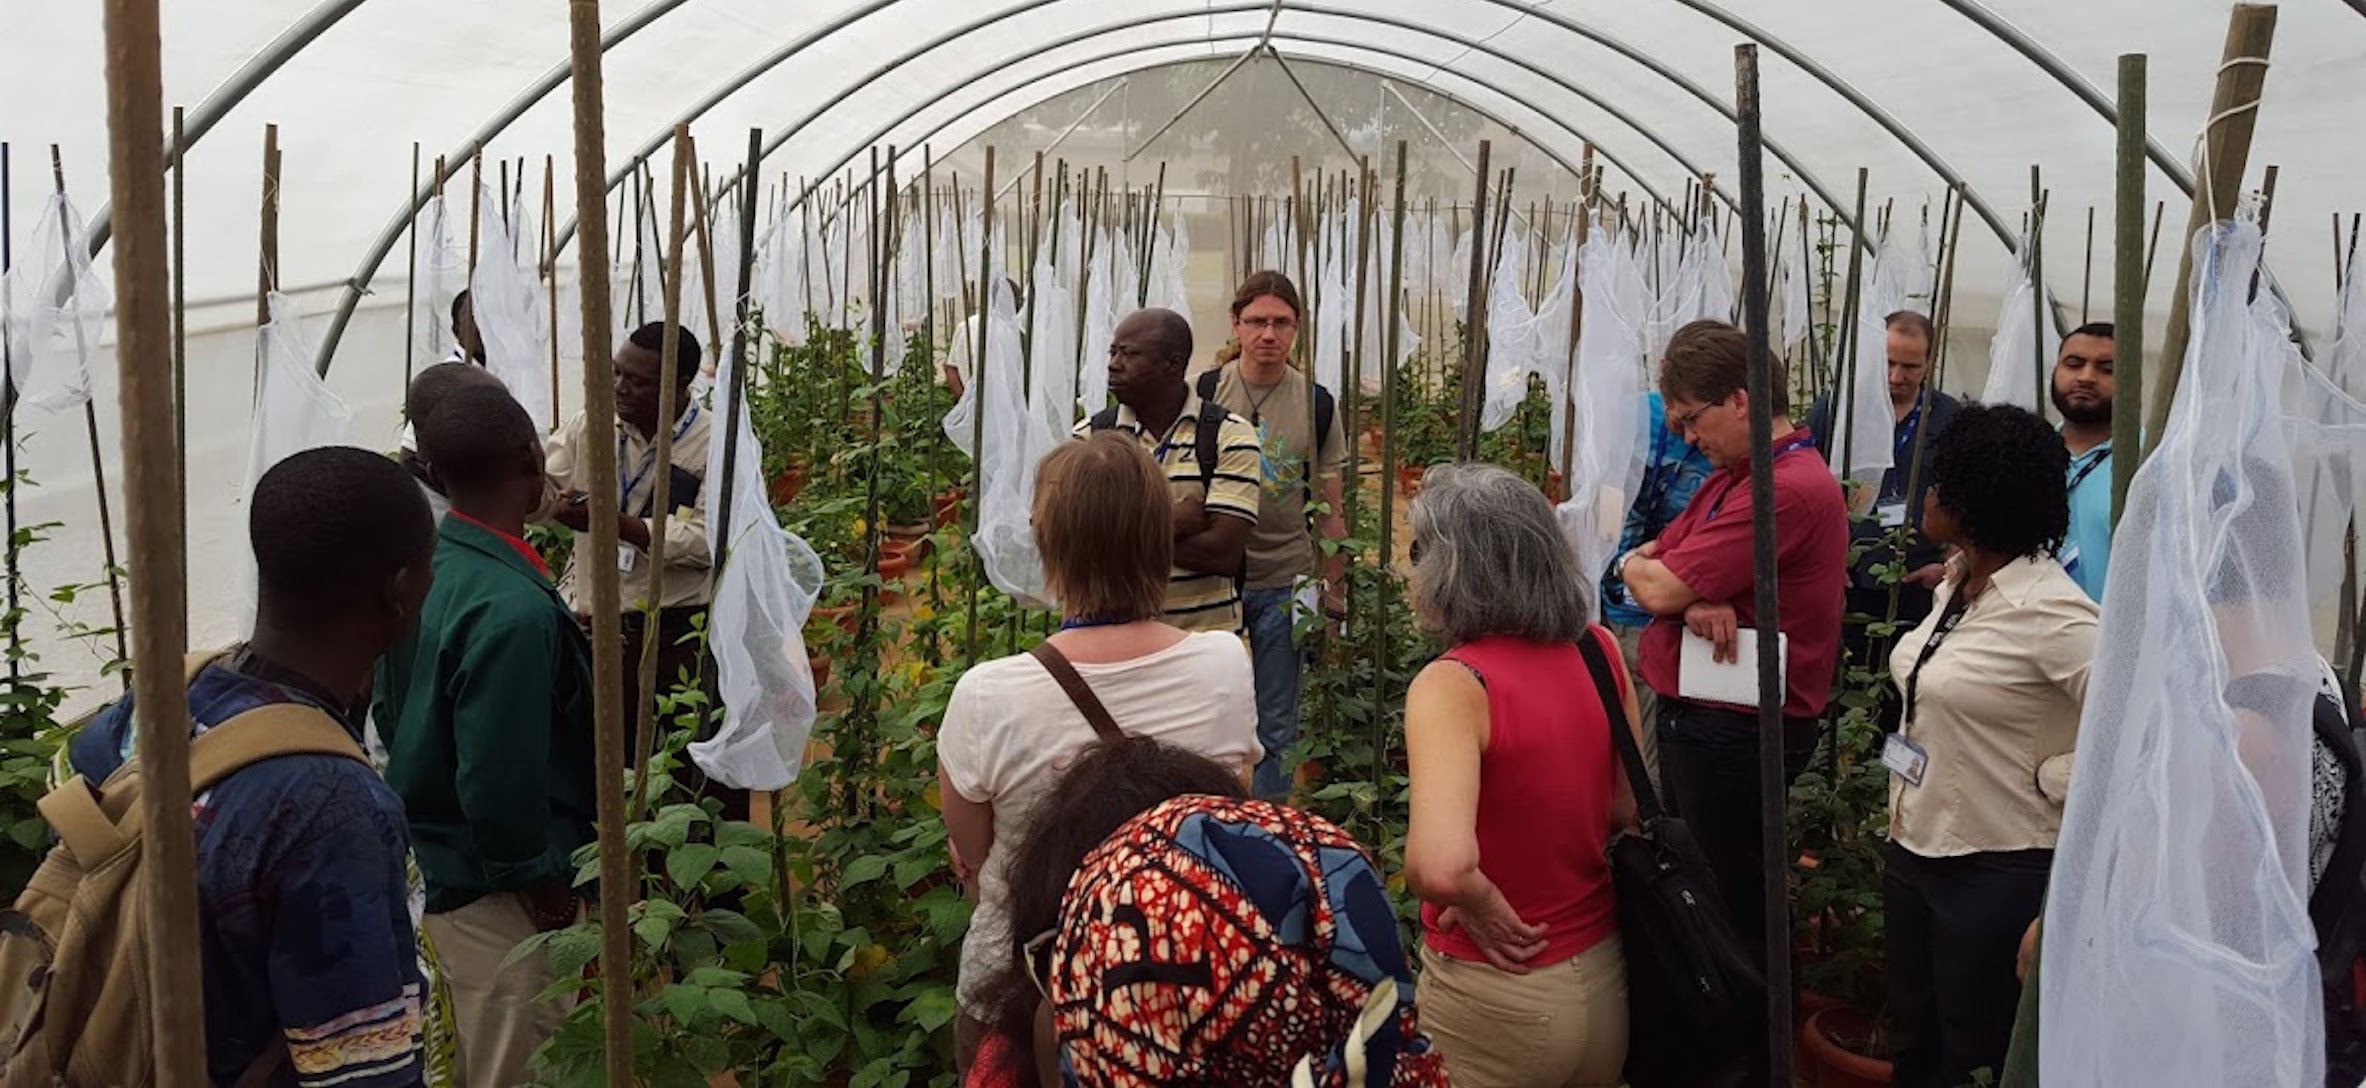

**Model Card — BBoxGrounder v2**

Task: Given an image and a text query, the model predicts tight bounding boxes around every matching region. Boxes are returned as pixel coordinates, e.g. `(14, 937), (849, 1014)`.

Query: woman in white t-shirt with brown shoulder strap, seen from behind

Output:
(937, 433), (1261, 1069)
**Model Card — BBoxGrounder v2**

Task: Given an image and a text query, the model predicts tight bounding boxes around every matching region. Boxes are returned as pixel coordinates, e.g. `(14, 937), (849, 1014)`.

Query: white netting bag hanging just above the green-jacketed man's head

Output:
(468, 189), (556, 433)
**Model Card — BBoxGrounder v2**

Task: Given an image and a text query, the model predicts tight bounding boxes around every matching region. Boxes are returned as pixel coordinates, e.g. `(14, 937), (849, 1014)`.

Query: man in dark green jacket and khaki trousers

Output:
(374, 388), (594, 1086)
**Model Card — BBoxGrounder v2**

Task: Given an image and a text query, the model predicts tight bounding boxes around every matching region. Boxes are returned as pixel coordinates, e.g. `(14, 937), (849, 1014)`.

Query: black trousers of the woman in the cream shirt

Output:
(1881, 844), (2054, 1088)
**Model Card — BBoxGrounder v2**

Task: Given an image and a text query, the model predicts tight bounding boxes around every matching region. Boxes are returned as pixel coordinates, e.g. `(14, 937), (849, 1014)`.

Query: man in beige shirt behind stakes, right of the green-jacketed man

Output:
(544, 322), (715, 747)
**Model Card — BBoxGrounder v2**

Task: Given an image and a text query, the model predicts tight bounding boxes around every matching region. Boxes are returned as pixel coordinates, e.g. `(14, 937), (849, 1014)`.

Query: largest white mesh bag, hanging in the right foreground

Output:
(2039, 222), (2323, 1088)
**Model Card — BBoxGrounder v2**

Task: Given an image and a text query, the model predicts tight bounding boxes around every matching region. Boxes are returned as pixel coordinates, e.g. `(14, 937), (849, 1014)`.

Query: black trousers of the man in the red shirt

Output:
(1659, 698), (1817, 963)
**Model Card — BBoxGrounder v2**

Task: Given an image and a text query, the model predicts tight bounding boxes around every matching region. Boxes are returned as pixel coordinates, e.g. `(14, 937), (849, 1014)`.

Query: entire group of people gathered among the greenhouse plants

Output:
(41, 256), (2340, 1086)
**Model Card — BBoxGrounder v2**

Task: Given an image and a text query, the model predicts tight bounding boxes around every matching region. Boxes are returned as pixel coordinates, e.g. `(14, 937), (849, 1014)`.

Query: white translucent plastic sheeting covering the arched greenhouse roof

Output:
(0, 0), (2366, 709)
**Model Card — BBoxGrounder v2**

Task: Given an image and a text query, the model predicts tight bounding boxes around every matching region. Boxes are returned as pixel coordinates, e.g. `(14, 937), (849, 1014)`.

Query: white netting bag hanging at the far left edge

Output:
(0, 194), (111, 412)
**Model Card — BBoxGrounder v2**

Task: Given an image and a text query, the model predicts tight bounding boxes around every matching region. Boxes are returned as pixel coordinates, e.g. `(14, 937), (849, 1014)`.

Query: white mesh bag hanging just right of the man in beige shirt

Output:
(691, 326), (826, 790)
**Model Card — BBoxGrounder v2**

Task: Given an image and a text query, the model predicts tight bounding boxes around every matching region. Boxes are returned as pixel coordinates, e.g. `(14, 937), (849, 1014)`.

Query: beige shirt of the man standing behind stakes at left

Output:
(542, 402), (715, 615)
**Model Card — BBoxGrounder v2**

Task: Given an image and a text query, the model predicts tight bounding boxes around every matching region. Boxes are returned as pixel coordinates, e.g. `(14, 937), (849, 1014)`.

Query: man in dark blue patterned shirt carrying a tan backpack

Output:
(69, 447), (435, 1088)
